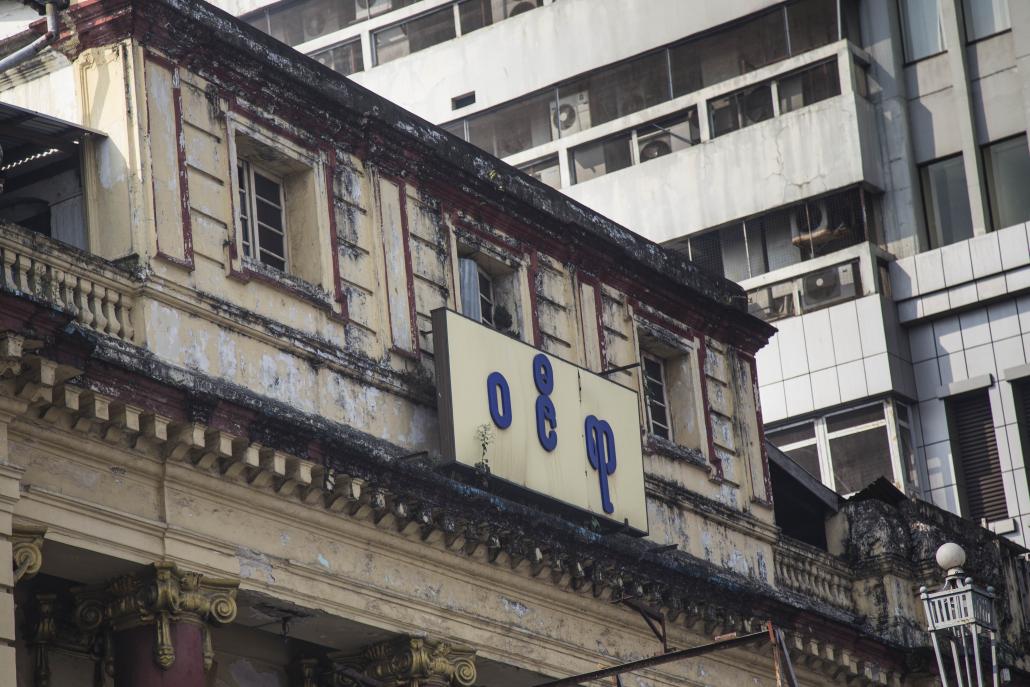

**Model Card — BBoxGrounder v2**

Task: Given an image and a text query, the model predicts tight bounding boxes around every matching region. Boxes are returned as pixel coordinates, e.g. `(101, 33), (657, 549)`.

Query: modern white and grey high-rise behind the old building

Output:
(198, 0), (1030, 543)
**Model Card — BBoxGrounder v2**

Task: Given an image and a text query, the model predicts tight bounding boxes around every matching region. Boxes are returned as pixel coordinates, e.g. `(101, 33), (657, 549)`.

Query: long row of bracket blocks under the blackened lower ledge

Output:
(0, 341), (927, 684)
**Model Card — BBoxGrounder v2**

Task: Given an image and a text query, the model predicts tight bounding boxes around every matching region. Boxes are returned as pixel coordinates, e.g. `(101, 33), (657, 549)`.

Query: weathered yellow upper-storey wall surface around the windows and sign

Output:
(68, 40), (771, 580)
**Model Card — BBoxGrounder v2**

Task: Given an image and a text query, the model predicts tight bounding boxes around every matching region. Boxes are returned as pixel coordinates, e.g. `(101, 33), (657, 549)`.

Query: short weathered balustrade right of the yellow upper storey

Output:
(776, 540), (854, 609)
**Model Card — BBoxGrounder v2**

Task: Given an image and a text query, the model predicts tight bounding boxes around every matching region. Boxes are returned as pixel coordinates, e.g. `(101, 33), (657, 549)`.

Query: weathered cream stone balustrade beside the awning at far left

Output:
(0, 224), (135, 342)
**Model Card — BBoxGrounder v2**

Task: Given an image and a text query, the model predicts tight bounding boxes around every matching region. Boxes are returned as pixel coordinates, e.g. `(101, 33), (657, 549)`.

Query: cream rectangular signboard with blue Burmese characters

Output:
(433, 309), (648, 533)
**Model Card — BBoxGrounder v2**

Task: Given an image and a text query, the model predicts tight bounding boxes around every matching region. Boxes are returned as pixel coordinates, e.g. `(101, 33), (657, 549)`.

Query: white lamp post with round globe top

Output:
(919, 543), (998, 687)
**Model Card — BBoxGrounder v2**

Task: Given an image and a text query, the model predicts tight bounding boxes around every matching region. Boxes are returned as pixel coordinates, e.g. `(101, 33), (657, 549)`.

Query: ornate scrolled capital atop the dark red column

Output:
(75, 561), (239, 671)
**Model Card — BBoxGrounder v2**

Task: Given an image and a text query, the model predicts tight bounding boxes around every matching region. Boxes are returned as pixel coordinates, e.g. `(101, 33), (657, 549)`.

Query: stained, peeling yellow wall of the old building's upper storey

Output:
(2, 16), (771, 589)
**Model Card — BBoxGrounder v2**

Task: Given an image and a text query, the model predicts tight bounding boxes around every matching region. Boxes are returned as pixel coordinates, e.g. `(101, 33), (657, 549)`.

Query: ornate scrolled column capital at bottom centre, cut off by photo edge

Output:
(334, 636), (476, 687)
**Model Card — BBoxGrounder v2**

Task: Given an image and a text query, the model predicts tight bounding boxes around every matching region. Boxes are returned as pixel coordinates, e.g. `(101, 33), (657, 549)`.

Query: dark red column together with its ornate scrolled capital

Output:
(75, 562), (238, 687)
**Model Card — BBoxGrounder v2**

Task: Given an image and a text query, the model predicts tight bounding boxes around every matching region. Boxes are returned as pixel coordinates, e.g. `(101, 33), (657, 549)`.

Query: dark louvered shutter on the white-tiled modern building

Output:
(948, 389), (1008, 522)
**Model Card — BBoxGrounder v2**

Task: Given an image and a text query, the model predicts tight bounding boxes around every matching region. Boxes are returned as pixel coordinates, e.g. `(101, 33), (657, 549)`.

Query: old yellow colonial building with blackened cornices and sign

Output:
(0, 0), (1030, 687)
